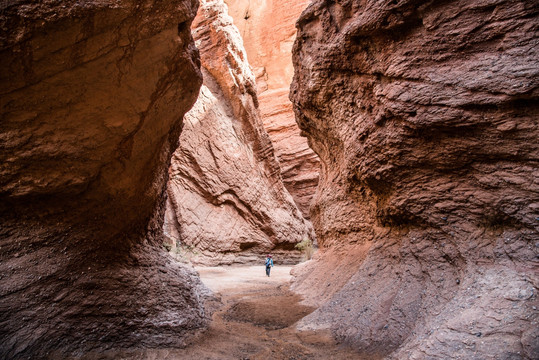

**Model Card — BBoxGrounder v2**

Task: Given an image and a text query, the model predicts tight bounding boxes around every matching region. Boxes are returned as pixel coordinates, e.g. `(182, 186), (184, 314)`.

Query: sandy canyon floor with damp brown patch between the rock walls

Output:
(79, 266), (358, 360)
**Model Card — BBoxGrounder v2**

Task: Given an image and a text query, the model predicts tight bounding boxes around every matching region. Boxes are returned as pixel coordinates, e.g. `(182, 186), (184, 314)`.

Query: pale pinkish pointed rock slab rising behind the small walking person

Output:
(165, 0), (313, 265)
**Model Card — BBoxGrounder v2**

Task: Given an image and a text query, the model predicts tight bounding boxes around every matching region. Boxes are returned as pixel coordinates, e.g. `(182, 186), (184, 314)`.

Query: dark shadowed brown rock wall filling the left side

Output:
(0, 0), (208, 359)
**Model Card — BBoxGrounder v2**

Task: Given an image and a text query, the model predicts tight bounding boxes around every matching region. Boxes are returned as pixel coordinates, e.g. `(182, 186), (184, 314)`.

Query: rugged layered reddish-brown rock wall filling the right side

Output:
(291, 0), (539, 359)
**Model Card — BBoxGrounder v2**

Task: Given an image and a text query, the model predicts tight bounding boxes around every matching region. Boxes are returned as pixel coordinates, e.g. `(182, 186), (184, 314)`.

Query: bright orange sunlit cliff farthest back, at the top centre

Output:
(225, 0), (319, 218)
